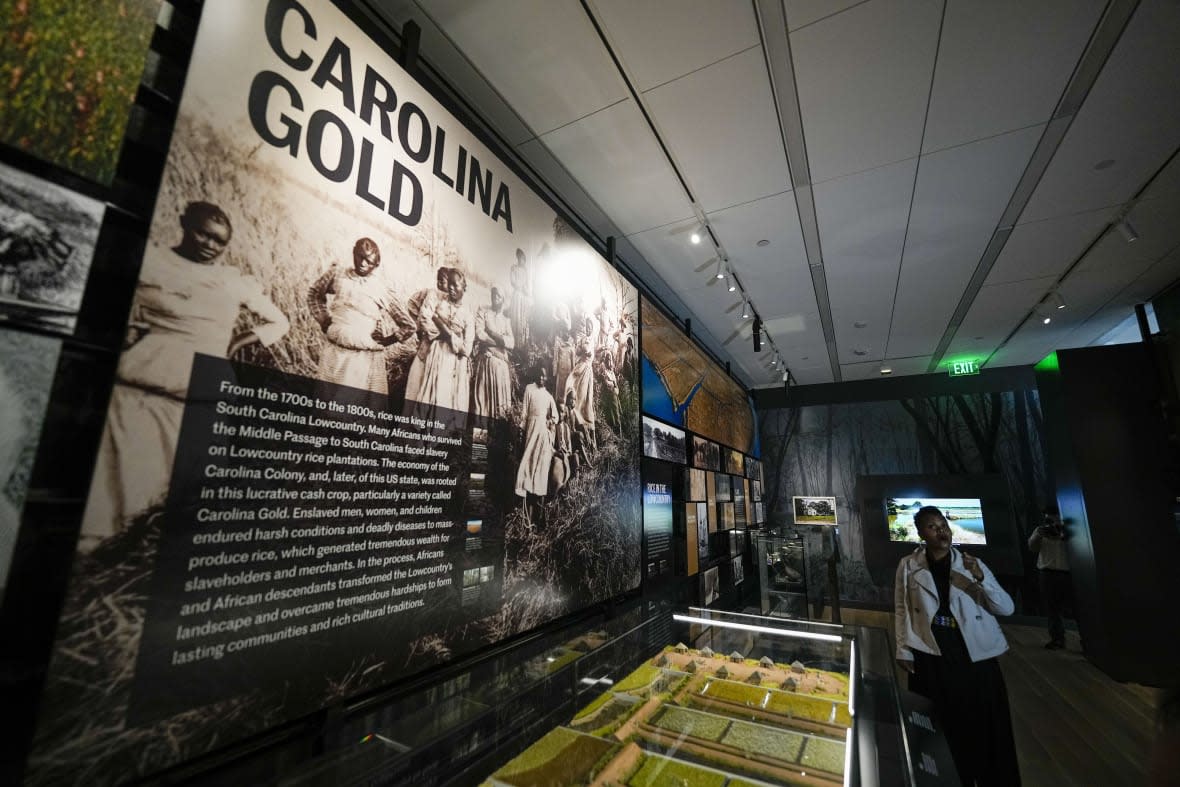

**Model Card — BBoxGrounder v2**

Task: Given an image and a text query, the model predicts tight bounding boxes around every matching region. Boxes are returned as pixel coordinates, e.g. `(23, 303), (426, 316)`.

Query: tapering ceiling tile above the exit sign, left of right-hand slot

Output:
(887, 127), (1041, 358)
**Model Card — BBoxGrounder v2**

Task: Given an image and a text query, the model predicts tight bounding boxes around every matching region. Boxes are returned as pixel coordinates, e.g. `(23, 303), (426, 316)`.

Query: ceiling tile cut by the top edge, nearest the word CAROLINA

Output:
(424, 0), (628, 135)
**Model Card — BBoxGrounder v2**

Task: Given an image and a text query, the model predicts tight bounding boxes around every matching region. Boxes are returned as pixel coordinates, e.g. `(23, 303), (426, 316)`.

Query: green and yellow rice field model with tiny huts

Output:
(487, 645), (852, 787)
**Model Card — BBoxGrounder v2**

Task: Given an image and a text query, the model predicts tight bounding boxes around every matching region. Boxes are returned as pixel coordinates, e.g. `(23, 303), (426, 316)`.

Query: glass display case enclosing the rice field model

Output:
(280, 604), (916, 787)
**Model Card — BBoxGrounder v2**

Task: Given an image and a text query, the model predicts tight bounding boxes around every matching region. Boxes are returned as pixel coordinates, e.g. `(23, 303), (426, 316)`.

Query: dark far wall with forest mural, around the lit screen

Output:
(755, 367), (1053, 611)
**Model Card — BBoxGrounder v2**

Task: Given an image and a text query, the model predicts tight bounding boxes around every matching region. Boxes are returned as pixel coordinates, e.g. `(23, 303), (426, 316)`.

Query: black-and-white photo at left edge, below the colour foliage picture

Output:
(0, 164), (105, 333)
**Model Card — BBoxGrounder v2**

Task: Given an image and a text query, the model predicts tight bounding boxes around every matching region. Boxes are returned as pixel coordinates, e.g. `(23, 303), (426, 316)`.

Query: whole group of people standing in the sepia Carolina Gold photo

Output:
(81, 201), (637, 551)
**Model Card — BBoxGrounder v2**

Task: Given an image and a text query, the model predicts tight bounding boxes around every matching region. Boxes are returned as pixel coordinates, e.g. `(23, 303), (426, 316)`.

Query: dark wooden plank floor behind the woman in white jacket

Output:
(816, 609), (1158, 787)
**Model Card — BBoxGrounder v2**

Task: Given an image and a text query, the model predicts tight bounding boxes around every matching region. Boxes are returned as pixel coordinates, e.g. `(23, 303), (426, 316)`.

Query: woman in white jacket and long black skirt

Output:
(893, 506), (1021, 787)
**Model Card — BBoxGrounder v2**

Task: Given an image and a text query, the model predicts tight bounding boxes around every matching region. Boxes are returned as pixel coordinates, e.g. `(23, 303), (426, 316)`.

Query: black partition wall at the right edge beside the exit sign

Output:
(1037, 343), (1180, 686)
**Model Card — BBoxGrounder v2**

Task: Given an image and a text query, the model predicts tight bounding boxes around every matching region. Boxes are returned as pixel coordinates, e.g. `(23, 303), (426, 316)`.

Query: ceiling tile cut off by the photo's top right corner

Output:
(1021, 2), (1180, 221)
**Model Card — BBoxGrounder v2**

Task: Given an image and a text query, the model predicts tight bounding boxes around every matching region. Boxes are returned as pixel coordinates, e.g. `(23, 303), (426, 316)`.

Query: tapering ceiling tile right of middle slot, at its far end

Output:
(815, 158), (918, 363)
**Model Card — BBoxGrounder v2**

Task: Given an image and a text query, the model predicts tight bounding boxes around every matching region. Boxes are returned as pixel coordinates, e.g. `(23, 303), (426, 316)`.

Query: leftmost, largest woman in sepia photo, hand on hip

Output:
(79, 202), (289, 551)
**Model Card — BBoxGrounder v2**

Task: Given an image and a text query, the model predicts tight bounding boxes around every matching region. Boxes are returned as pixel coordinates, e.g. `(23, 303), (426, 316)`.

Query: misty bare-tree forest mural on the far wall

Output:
(759, 389), (1053, 604)
